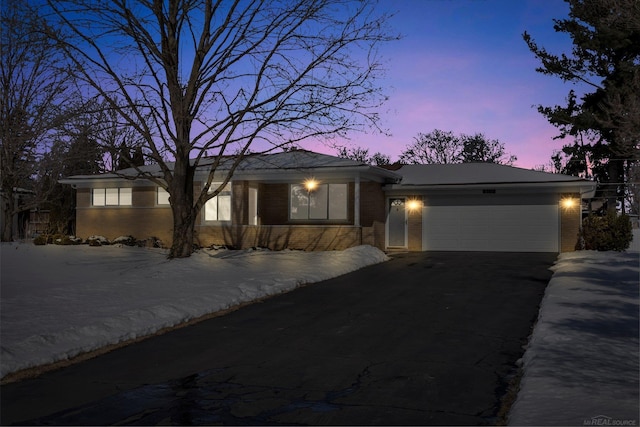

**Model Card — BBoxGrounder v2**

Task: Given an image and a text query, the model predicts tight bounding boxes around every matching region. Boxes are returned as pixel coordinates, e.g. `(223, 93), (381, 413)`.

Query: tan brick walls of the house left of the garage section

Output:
(76, 181), (385, 250)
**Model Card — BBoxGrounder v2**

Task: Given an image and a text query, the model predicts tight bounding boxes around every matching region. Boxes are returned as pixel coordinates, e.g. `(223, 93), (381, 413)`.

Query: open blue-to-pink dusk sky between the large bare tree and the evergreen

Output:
(305, 0), (580, 168)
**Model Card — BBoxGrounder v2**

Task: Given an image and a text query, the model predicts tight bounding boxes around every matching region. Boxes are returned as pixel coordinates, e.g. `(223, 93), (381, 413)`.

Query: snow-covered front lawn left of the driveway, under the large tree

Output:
(0, 244), (388, 377)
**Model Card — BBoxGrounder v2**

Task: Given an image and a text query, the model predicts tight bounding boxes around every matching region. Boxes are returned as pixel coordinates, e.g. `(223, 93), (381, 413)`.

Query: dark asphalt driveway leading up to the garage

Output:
(0, 252), (556, 425)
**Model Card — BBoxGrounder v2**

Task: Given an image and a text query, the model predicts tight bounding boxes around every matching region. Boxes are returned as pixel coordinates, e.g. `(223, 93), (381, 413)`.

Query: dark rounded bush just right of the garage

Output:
(578, 213), (633, 251)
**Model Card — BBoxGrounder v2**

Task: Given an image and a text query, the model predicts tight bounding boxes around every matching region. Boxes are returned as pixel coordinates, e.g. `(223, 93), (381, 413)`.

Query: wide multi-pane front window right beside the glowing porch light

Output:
(289, 184), (348, 220)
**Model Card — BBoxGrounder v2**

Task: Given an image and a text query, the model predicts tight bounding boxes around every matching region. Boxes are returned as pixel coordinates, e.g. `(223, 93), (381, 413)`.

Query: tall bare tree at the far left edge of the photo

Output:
(0, 0), (73, 241)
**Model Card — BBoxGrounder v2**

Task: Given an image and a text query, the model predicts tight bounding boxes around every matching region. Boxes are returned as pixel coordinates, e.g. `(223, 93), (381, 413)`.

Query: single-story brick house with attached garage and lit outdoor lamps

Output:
(61, 150), (595, 252)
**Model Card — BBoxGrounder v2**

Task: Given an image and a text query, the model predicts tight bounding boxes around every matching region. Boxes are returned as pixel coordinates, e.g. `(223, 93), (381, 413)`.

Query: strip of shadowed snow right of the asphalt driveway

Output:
(509, 251), (640, 426)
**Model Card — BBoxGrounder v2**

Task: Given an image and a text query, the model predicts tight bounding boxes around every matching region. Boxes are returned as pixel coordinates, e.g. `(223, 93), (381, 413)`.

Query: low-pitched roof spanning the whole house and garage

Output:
(60, 150), (596, 193)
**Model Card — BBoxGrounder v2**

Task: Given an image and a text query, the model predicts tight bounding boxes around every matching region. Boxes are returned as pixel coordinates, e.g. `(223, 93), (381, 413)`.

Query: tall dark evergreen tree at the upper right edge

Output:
(523, 0), (640, 210)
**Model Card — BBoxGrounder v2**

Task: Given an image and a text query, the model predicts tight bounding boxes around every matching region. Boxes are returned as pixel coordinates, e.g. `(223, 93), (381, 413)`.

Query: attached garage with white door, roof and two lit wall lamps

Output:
(385, 163), (595, 252)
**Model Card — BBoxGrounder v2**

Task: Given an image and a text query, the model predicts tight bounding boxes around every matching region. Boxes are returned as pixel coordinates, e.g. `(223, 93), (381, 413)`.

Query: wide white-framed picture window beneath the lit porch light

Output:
(289, 183), (349, 222)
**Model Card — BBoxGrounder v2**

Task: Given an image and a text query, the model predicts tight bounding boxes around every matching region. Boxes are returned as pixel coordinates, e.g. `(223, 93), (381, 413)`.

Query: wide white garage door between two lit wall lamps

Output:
(422, 205), (559, 252)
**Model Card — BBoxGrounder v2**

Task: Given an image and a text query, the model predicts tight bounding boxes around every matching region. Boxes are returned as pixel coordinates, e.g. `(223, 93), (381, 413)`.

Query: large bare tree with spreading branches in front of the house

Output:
(43, 0), (395, 257)
